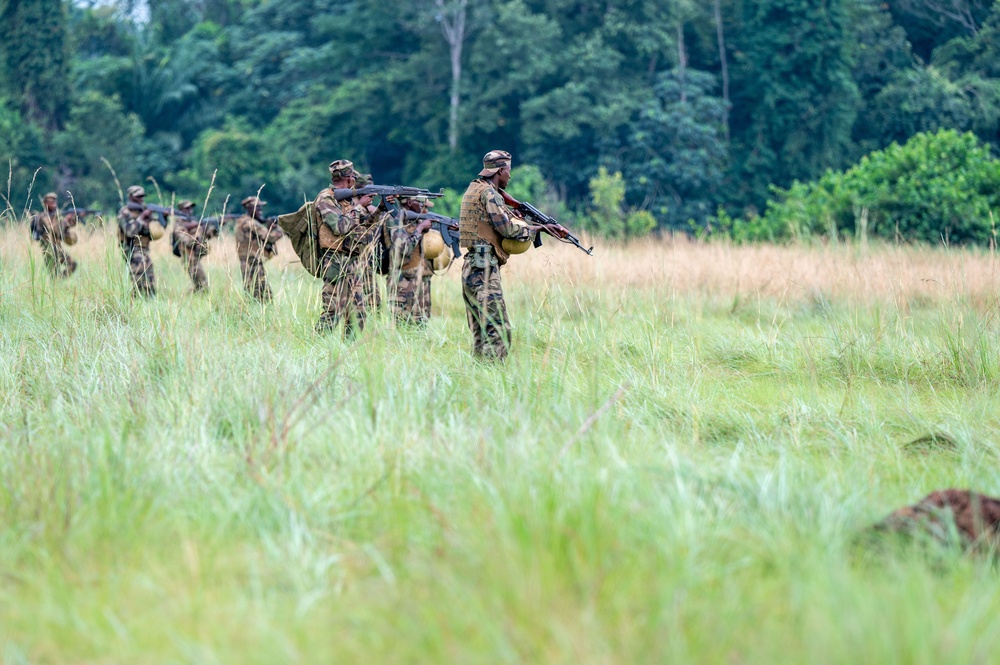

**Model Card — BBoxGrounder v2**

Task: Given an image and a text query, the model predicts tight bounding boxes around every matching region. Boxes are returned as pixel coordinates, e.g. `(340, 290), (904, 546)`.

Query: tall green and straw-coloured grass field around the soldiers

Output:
(0, 220), (1000, 665)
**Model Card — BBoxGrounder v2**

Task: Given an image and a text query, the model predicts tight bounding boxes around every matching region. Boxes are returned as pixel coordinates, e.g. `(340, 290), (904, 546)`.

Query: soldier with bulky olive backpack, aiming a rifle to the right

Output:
(315, 159), (384, 337)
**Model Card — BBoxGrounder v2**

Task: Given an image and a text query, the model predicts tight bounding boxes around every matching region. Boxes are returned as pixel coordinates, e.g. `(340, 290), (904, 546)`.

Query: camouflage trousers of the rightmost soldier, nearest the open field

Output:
(462, 252), (511, 361)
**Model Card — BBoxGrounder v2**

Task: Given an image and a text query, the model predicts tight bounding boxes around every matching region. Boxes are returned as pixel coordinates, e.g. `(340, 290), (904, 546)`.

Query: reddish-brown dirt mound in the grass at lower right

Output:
(872, 489), (1000, 548)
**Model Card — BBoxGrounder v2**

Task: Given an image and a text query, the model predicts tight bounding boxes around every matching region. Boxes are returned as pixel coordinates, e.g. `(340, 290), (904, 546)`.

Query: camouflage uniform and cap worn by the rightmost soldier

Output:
(459, 150), (533, 360)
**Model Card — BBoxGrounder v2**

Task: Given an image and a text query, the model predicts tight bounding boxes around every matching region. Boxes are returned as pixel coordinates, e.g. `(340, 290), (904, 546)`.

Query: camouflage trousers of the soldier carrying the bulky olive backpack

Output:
(316, 254), (381, 337)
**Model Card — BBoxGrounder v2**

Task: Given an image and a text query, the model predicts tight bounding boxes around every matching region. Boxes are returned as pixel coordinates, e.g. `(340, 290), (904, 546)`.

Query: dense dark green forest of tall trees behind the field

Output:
(0, 0), (1000, 240)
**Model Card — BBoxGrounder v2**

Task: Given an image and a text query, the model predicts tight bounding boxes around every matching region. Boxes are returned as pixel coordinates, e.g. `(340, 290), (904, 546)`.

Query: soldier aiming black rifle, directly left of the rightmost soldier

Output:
(388, 196), (434, 325)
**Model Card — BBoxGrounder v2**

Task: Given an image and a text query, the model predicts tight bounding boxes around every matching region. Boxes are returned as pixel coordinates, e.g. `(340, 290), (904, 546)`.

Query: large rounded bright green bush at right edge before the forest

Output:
(756, 131), (1000, 244)
